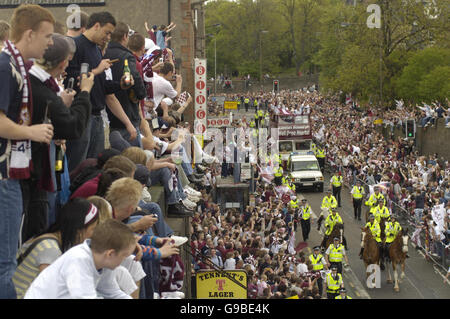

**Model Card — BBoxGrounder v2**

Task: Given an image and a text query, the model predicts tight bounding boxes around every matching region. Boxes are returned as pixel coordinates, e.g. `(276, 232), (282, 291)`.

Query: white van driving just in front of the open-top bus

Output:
(287, 153), (324, 192)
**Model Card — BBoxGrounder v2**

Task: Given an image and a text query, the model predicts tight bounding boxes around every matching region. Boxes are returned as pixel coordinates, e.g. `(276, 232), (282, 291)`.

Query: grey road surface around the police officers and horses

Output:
(296, 174), (450, 299)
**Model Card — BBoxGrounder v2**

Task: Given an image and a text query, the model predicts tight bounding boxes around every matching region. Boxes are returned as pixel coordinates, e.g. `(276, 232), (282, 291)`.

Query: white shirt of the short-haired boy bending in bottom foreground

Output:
(24, 239), (131, 299)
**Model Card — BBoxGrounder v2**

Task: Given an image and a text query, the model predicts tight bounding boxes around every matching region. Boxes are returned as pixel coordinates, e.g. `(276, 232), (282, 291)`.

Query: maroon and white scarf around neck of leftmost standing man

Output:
(3, 41), (33, 179)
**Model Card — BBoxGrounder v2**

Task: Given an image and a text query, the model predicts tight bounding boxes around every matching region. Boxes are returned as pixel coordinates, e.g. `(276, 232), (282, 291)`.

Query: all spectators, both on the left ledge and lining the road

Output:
(0, 4), (450, 299)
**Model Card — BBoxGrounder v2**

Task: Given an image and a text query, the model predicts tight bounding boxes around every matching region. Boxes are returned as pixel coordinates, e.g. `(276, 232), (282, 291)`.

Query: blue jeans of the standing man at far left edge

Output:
(0, 179), (23, 299)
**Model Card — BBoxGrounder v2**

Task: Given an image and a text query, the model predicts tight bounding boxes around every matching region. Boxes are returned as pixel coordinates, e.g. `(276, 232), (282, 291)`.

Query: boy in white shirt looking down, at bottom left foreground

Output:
(24, 219), (137, 299)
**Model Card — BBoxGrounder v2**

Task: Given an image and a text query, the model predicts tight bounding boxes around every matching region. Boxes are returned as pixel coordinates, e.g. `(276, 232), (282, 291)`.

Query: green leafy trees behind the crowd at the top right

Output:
(205, 0), (450, 101)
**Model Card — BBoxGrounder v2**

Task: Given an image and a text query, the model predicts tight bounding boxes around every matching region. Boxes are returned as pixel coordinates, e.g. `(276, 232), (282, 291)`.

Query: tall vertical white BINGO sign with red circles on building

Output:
(194, 59), (207, 134)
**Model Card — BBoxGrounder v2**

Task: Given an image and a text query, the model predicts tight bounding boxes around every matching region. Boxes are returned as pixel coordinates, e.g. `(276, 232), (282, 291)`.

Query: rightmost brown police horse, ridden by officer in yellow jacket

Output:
(387, 229), (408, 292)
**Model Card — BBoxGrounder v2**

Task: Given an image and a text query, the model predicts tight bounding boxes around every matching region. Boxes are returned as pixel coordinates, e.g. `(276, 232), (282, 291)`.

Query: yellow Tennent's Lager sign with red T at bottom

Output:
(196, 270), (247, 299)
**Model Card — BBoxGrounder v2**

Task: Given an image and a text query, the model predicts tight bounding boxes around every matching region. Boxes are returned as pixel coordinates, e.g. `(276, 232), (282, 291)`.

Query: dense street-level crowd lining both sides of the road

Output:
(191, 90), (450, 298)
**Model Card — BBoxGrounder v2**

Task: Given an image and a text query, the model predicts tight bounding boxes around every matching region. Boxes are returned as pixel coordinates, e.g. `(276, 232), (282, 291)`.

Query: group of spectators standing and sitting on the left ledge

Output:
(0, 4), (214, 298)
